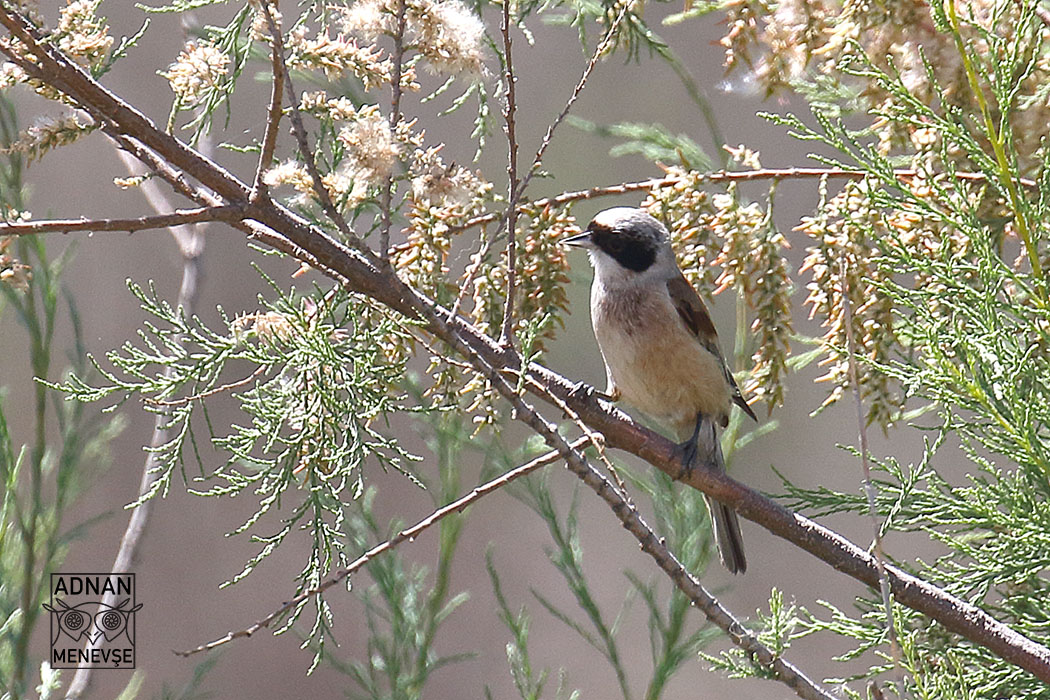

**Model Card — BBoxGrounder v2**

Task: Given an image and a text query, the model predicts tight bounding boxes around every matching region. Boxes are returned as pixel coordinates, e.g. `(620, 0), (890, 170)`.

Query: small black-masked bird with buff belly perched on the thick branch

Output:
(562, 207), (757, 574)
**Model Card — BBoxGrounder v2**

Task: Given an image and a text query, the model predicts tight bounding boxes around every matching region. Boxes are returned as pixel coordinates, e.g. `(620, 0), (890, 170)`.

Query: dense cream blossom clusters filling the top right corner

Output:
(721, 0), (1050, 172)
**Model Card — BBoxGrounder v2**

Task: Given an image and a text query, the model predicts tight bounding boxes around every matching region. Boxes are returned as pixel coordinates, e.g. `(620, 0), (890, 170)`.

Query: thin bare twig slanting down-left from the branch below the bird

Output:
(175, 437), (590, 656)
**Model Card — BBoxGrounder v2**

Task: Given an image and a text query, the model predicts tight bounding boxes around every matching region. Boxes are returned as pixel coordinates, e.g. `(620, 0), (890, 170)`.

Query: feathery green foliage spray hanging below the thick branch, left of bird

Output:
(51, 280), (421, 617)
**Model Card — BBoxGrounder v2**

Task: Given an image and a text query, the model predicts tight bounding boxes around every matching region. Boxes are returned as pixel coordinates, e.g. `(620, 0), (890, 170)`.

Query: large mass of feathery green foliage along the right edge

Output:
(720, 3), (1050, 698)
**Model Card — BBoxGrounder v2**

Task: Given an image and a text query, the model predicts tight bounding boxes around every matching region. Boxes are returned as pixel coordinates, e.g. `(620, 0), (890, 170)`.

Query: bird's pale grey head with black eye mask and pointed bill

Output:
(562, 207), (674, 281)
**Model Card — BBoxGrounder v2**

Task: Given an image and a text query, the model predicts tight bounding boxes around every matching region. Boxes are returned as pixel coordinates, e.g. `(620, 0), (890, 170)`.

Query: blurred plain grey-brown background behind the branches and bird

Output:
(0, 1), (936, 700)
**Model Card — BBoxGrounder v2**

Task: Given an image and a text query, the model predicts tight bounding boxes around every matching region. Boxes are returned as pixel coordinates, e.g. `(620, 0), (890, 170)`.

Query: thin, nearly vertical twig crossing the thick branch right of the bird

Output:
(839, 256), (904, 683)
